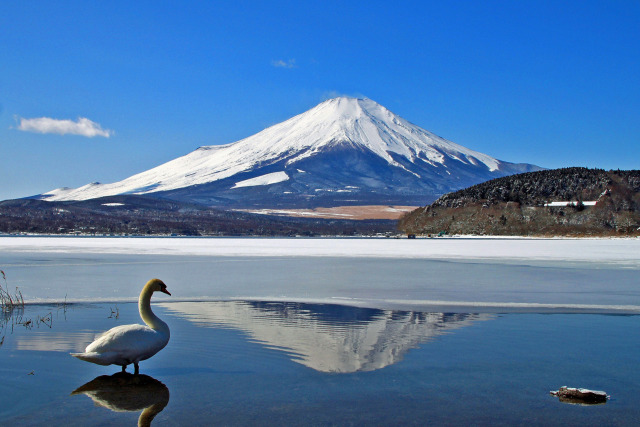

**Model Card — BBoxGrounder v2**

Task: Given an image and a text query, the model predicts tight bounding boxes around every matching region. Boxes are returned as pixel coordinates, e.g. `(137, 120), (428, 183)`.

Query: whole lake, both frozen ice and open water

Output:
(0, 238), (640, 425)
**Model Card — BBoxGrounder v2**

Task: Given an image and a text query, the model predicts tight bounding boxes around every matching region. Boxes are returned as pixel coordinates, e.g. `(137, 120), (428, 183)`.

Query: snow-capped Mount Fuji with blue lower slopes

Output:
(34, 97), (542, 208)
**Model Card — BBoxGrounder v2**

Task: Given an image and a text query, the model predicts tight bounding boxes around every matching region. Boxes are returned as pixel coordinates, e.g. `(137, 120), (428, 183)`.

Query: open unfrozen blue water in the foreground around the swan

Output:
(0, 298), (640, 425)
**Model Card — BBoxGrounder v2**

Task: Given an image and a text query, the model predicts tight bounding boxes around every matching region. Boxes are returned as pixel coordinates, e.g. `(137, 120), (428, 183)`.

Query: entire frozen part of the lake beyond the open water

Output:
(0, 237), (640, 313)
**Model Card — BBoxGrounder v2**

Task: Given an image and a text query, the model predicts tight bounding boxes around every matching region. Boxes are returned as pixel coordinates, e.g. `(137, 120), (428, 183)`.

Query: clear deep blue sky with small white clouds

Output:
(0, 0), (640, 200)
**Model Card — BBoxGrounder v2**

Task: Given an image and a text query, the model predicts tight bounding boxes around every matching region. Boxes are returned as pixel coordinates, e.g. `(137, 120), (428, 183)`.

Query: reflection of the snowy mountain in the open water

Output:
(160, 301), (493, 373)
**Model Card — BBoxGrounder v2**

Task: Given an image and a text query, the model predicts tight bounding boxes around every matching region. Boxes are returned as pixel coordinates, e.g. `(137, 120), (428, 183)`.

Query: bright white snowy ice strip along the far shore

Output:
(0, 237), (640, 267)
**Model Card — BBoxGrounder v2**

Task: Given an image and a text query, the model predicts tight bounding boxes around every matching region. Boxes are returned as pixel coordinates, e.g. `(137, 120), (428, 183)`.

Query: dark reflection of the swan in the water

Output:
(71, 372), (169, 426)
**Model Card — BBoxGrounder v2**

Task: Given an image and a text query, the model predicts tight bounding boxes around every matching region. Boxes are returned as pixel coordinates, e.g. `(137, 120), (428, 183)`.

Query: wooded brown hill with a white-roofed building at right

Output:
(399, 167), (640, 236)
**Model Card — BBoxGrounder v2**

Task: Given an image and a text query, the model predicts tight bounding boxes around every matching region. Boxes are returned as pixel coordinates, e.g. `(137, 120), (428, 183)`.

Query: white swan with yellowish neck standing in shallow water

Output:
(71, 279), (171, 374)
